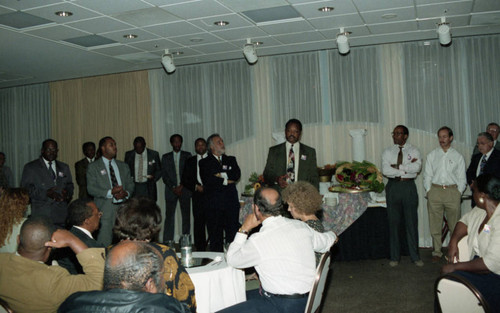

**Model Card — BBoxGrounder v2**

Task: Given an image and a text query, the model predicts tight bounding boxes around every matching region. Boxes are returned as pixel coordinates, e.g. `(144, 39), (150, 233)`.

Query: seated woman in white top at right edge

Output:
(441, 174), (500, 312)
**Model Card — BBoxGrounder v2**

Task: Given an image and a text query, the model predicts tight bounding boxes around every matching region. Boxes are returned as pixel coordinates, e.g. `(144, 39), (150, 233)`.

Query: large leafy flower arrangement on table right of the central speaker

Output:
(335, 161), (384, 192)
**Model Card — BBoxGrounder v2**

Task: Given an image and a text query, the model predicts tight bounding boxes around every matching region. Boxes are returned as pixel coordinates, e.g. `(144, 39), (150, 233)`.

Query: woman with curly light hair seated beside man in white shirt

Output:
(282, 181), (325, 265)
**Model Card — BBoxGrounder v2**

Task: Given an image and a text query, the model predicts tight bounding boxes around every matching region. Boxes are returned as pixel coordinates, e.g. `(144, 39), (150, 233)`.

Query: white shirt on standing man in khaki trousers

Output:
(424, 147), (467, 192)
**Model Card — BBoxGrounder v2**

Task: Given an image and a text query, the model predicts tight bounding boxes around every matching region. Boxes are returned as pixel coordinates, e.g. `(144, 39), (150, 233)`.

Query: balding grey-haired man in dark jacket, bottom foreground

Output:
(58, 241), (190, 313)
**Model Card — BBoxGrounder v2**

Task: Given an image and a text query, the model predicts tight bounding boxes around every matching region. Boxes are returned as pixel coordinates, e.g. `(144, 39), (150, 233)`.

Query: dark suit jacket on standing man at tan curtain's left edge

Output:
(21, 157), (74, 224)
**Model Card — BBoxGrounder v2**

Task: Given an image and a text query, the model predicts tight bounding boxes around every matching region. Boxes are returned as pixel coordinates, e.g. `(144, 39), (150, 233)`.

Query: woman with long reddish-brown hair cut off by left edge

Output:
(0, 188), (30, 252)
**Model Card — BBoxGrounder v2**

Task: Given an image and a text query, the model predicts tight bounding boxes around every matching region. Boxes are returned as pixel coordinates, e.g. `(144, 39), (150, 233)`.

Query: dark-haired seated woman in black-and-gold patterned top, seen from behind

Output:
(113, 197), (196, 313)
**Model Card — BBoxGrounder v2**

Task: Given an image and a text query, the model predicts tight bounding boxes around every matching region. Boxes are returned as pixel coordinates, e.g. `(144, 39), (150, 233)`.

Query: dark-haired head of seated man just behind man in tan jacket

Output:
(66, 199), (102, 233)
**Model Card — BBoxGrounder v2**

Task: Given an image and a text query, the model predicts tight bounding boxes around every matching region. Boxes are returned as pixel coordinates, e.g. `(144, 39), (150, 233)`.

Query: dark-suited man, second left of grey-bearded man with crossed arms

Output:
(161, 134), (191, 242)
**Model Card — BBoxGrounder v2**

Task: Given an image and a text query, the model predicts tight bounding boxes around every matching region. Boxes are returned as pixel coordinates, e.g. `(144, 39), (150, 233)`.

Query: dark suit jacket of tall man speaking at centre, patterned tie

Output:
(264, 142), (319, 190)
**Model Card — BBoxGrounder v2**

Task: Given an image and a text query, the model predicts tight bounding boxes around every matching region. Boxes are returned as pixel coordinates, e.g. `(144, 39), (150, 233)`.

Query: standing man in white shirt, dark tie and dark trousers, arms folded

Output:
(382, 125), (424, 267)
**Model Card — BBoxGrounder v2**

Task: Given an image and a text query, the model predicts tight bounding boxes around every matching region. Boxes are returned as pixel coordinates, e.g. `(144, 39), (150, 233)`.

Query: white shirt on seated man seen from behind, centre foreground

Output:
(227, 216), (336, 294)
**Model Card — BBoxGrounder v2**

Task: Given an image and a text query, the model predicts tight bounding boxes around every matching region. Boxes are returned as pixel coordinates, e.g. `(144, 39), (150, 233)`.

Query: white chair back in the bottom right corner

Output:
(434, 273), (490, 313)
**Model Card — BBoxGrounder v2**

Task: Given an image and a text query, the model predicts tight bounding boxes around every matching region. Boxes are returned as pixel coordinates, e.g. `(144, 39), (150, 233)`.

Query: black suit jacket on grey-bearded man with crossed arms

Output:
(199, 153), (241, 209)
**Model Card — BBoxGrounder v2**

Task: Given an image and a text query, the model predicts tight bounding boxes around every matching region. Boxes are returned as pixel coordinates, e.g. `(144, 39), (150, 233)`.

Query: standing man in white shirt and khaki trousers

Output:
(424, 126), (467, 263)
